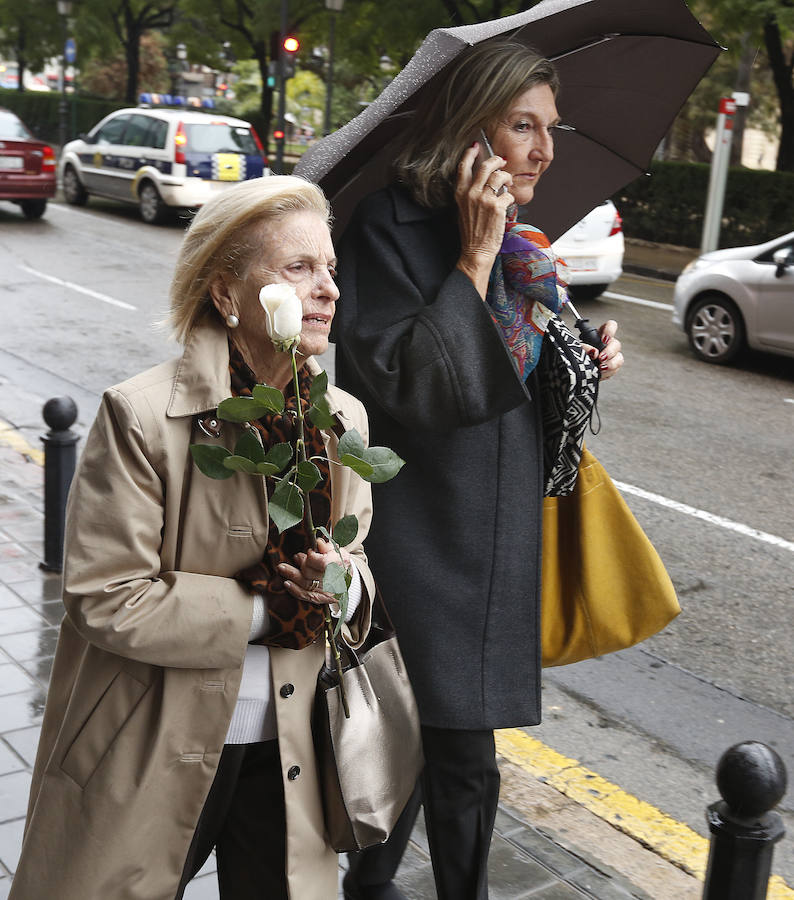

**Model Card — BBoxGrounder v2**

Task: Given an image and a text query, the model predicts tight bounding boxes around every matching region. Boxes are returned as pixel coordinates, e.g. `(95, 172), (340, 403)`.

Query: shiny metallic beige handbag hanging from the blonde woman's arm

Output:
(312, 592), (424, 853)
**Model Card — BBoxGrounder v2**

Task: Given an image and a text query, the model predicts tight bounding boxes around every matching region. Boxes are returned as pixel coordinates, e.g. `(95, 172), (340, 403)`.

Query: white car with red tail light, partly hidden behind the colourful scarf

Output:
(551, 200), (625, 300)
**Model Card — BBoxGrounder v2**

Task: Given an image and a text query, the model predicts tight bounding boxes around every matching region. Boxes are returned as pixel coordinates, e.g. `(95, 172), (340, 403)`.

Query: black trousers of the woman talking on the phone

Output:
(349, 726), (499, 900)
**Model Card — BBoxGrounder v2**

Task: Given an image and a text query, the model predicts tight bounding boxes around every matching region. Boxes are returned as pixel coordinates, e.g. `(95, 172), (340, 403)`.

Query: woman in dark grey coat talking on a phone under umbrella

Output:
(336, 41), (623, 900)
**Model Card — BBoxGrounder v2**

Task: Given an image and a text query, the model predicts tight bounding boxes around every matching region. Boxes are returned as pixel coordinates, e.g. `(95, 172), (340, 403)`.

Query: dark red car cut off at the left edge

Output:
(0, 107), (55, 219)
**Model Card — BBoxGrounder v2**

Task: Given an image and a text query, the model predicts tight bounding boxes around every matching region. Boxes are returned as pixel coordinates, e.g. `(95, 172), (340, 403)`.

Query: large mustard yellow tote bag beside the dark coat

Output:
(541, 448), (681, 667)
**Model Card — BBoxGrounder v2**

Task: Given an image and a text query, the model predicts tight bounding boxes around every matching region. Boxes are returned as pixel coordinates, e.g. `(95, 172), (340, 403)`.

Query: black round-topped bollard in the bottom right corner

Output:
(703, 741), (786, 900)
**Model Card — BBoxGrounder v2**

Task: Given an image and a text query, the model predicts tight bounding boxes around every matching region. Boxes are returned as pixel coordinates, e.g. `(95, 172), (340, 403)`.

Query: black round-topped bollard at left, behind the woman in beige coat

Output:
(39, 397), (80, 572)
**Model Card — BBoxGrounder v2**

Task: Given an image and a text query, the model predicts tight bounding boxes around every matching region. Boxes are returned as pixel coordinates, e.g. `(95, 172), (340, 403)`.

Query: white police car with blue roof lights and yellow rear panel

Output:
(59, 107), (270, 224)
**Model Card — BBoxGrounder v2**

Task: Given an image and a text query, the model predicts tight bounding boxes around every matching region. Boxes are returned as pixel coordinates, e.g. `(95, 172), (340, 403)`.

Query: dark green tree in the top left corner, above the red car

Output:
(0, 0), (63, 91)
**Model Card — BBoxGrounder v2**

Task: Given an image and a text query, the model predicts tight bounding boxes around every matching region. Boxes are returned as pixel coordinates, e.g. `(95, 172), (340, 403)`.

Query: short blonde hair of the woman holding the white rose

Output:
(168, 175), (331, 343)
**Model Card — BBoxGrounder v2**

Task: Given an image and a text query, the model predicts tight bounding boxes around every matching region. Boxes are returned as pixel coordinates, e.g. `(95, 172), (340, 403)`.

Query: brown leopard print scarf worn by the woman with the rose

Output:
(229, 341), (331, 650)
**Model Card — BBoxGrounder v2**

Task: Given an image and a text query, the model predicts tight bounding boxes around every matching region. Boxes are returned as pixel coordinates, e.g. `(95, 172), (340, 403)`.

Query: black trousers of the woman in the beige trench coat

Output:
(175, 741), (287, 900)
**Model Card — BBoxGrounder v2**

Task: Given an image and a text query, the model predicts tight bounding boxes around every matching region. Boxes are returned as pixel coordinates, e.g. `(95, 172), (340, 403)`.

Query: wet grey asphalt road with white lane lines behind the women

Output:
(0, 201), (794, 884)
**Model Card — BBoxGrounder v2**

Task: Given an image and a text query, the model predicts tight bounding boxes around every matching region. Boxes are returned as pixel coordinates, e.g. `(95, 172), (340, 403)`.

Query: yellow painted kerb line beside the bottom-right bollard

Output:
(496, 728), (794, 900)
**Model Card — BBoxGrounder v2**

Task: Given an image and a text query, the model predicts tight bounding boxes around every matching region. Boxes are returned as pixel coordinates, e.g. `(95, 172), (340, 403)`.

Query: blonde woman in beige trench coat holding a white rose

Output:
(11, 177), (374, 900)
